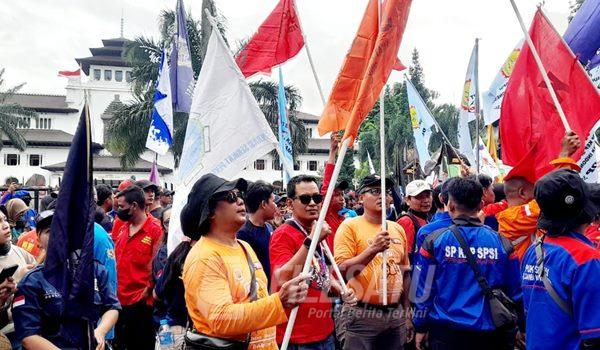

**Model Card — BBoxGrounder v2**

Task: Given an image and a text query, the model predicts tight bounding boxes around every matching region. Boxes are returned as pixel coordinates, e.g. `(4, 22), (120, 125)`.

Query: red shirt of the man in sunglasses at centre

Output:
(269, 224), (333, 344)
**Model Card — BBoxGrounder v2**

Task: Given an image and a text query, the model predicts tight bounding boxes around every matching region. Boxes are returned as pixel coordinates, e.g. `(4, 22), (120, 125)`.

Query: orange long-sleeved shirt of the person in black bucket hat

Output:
(183, 237), (287, 350)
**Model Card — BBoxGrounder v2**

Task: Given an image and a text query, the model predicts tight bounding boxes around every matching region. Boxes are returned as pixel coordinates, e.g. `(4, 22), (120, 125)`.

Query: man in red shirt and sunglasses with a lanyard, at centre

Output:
(269, 175), (355, 350)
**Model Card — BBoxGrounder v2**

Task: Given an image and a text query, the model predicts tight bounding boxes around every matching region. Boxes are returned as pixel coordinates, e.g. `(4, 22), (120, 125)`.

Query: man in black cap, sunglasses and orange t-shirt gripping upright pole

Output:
(334, 175), (413, 350)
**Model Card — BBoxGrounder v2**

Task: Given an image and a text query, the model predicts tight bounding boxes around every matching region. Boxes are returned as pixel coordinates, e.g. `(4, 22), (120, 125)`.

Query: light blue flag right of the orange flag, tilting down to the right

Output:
(406, 79), (435, 171)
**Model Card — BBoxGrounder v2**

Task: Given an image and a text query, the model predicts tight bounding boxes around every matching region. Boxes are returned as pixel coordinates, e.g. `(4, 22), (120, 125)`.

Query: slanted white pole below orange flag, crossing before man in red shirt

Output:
(281, 138), (350, 350)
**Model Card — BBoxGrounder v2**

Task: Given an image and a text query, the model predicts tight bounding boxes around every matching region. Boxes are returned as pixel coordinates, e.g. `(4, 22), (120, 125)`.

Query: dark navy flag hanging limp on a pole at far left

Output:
(44, 104), (95, 326)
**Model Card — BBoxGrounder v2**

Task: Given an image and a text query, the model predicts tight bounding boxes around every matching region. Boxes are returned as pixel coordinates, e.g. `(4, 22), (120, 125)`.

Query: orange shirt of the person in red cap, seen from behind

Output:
(496, 199), (540, 260)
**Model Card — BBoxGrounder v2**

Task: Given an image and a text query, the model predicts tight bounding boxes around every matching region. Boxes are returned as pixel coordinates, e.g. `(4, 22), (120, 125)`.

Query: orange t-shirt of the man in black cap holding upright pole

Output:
(334, 216), (409, 305)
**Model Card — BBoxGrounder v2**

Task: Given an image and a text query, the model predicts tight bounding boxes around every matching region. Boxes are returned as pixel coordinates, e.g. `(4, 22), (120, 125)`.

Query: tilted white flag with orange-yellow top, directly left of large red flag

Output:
(481, 40), (523, 125)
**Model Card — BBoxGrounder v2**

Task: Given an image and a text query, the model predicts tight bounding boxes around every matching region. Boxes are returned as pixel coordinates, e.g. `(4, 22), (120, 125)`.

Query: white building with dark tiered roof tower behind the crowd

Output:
(0, 38), (329, 190)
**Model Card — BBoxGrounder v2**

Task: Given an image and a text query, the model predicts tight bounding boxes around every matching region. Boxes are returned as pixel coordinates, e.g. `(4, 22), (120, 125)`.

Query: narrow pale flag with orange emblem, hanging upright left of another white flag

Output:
(458, 42), (479, 165)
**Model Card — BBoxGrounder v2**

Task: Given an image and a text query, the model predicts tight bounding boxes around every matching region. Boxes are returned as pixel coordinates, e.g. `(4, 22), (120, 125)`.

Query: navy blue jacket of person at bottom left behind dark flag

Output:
(12, 263), (121, 349)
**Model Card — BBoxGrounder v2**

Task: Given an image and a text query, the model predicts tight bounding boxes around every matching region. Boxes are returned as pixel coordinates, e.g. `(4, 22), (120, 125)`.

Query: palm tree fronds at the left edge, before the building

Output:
(0, 68), (37, 151)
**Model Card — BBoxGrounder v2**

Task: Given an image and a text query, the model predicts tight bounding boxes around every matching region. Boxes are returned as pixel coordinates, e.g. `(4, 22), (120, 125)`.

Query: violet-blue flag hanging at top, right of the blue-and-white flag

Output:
(170, 0), (195, 113)
